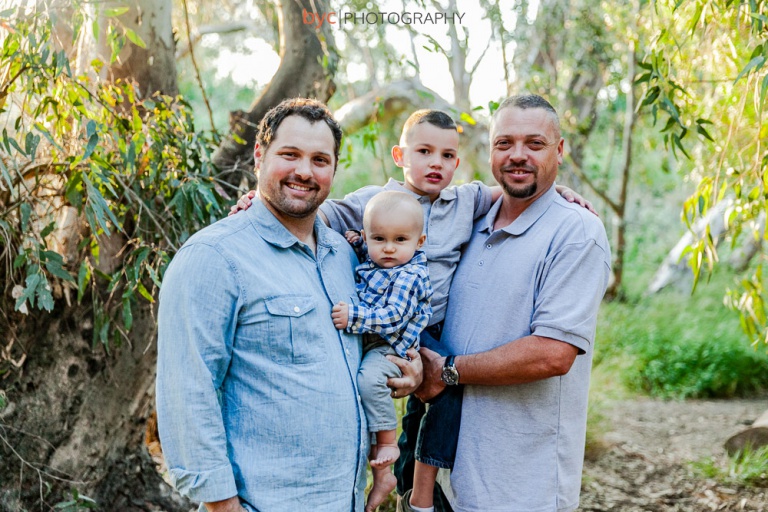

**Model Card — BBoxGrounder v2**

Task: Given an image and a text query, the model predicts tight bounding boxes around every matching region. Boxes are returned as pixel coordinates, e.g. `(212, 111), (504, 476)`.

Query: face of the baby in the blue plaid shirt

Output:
(363, 208), (427, 268)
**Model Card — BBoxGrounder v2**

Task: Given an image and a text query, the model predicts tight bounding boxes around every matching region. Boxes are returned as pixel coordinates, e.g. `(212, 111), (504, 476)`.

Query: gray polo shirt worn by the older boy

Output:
(320, 179), (491, 325)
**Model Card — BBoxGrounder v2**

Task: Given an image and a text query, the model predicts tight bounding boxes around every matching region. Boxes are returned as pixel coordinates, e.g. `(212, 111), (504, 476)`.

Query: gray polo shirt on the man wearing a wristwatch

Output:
(443, 186), (611, 512)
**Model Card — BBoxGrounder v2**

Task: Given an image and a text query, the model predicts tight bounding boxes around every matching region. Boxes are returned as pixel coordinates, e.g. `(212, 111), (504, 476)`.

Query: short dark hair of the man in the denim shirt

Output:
(256, 98), (342, 167)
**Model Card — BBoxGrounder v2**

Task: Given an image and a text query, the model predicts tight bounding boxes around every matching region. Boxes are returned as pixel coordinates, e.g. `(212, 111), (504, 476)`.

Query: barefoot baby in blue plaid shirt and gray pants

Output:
(332, 191), (432, 508)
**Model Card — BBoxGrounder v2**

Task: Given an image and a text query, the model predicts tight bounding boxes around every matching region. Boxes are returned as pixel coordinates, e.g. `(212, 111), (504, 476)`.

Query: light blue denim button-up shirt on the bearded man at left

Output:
(157, 201), (368, 512)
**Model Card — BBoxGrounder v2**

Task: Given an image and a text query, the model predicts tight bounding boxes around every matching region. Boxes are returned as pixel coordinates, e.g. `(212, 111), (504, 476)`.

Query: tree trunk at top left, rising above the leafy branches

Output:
(98, 0), (179, 98)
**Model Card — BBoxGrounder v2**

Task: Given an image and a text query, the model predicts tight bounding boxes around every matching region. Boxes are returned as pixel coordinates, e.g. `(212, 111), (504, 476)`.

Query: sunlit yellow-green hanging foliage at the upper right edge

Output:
(636, 0), (768, 348)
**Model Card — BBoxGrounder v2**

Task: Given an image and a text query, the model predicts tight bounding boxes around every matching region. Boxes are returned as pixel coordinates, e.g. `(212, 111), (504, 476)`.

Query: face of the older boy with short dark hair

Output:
(392, 123), (459, 201)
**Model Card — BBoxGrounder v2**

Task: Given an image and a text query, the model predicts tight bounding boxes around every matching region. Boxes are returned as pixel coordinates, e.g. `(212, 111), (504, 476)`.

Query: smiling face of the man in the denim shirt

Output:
(254, 115), (336, 218)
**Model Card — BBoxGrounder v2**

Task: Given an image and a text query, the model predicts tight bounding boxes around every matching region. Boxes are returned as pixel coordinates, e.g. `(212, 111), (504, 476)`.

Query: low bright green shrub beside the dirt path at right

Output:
(595, 275), (768, 398)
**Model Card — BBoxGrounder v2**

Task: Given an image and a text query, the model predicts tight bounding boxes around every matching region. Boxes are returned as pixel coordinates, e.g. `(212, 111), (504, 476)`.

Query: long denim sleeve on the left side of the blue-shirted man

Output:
(157, 244), (239, 501)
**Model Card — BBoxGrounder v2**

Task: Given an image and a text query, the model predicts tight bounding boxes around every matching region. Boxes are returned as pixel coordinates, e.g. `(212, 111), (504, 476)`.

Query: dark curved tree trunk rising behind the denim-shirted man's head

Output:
(213, 0), (338, 185)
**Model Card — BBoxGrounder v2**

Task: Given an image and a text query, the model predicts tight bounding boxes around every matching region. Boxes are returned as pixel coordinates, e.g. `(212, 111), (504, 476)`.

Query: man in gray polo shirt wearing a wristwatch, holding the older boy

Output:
(418, 95), (611, 512)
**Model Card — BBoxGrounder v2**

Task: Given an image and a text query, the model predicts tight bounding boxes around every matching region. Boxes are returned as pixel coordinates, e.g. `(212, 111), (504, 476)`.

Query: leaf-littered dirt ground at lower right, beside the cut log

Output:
(580, 397), (768, 512)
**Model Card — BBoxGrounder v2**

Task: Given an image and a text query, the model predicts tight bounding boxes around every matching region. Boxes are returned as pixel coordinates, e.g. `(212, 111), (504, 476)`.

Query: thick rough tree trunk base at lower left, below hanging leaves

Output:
(0, 304), (193, 512)
